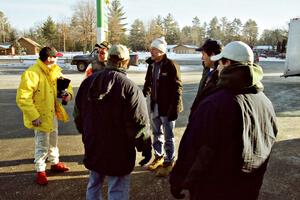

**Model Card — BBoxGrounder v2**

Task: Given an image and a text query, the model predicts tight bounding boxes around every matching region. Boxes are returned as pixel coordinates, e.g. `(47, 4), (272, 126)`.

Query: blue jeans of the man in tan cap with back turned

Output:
(86, 170), (130, 200)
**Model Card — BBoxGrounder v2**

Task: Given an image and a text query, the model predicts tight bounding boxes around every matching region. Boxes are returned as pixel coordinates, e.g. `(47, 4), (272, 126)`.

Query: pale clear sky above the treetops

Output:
(0, 0), (300, 31)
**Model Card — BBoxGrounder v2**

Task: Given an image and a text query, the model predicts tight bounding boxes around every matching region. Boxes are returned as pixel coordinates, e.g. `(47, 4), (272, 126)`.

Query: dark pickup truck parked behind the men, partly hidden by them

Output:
(71, 49), (139, 72)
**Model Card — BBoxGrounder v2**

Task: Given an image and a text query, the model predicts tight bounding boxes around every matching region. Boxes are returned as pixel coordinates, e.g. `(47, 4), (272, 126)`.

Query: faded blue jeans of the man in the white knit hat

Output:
(151, 115), (175, 163)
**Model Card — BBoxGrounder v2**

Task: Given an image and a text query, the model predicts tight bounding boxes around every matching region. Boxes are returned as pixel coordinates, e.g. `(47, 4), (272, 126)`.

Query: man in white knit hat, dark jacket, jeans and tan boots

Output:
(143, 37), (183, 176)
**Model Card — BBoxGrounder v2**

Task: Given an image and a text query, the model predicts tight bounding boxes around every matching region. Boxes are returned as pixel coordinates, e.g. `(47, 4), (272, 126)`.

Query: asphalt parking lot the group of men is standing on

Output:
(0, 62), (300, 200)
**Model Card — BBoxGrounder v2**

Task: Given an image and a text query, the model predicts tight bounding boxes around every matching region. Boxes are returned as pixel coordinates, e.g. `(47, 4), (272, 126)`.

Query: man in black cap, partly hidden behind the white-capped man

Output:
(190, 39), (222, 116)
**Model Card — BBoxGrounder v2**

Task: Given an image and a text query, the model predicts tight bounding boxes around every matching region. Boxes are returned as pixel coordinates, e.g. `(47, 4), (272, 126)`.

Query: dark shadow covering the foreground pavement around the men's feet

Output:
(0, 139), (300, 200)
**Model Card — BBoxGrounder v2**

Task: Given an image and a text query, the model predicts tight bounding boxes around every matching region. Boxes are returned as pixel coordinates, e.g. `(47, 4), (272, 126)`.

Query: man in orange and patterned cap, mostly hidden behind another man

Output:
(85, 41), (111, 77)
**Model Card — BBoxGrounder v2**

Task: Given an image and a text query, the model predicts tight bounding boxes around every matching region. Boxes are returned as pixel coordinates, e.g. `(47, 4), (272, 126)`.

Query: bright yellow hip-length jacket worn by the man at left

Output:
(16, 59), (73, 132)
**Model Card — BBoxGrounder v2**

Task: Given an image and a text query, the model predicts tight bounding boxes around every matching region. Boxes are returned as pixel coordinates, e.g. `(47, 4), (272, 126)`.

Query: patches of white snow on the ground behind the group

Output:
(0, 52), (285, 72)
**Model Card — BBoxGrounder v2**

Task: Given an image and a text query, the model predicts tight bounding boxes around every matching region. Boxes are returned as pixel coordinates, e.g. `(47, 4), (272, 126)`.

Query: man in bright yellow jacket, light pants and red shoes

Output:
(16, 47), (73, 185)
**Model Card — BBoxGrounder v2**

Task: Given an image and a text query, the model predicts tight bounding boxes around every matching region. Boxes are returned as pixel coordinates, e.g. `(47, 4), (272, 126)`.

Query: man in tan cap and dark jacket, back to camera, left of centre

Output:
(74, 45), (151, 200)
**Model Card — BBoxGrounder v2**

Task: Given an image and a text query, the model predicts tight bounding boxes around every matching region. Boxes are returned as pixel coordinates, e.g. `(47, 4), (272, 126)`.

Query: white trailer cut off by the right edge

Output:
(282, 18), (300, 77)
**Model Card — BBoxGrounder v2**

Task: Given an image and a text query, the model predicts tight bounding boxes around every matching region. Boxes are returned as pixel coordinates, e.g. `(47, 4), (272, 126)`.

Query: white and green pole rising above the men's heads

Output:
(96, 0), (109, 44)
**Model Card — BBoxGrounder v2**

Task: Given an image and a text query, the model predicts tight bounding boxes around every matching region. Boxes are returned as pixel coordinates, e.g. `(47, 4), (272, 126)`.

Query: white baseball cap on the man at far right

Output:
(210, 41), (254, 63)
